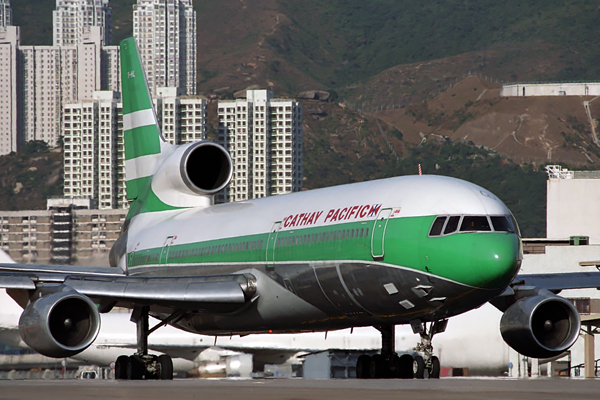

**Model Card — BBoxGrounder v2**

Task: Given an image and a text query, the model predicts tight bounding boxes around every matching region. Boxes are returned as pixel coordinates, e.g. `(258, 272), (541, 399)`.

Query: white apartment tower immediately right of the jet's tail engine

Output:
(218, 90), (302, 201)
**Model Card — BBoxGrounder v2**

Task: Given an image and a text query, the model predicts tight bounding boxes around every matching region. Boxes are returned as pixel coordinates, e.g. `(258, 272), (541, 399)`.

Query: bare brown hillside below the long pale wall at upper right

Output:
(369, 76), (600, 166)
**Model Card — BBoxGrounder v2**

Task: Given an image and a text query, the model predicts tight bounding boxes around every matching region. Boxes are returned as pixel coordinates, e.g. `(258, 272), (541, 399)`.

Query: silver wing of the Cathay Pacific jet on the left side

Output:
(0, 264), (256, 312)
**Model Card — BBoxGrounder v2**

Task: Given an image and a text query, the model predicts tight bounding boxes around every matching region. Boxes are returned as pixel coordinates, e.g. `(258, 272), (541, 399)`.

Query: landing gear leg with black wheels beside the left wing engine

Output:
(115, 307), (173, 380)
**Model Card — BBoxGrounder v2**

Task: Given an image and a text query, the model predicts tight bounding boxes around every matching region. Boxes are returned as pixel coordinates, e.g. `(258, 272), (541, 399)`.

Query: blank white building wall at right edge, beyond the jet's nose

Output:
(546, 179), (600, 244)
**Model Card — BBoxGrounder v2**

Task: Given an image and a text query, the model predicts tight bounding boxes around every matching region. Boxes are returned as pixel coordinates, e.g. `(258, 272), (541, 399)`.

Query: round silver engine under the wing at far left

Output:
(19, 286), (100, 358)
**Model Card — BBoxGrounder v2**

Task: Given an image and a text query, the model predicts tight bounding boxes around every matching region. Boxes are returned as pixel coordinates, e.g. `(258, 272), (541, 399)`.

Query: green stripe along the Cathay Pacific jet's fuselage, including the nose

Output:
(128, 216), (519, 288)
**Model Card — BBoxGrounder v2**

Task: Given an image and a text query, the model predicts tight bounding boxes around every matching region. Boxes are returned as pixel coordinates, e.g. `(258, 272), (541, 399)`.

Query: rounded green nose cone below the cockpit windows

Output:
(471, 232), (523, 289)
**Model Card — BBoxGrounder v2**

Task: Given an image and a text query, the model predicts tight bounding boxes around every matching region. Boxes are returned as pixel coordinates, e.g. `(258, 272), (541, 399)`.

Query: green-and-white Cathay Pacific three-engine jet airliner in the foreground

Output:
(0, 38), (600, 379)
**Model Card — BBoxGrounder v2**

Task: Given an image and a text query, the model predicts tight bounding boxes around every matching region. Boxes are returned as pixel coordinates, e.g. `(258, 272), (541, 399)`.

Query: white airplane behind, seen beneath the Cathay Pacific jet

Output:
(0, 276), (509, 375)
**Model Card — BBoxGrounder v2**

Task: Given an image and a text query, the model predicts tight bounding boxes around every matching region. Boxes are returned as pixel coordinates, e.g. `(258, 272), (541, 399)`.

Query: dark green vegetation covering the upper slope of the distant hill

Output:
(271, 0), (600, 87)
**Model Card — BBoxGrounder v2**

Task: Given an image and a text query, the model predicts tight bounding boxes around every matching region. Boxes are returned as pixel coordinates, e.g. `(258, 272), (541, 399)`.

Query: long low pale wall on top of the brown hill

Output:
(500, 82), (600, 97)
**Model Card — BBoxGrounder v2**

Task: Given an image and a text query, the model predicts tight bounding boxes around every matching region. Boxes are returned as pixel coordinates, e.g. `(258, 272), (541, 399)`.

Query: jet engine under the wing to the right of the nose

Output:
(500, 290), (581, 358)
